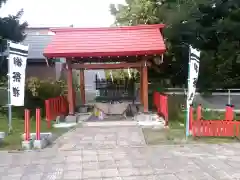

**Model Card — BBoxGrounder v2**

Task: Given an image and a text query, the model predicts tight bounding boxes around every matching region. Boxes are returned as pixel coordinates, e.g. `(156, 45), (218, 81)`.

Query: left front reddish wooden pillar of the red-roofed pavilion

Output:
(67, 60), (74, 115)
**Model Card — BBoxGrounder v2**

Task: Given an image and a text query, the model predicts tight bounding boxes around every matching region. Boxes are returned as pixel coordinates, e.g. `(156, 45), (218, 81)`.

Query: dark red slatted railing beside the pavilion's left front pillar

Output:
(45, 96), (68, 128)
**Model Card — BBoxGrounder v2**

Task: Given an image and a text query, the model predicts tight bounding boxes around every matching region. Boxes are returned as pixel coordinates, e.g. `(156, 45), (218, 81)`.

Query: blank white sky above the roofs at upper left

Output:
(0, 0), (125, 27)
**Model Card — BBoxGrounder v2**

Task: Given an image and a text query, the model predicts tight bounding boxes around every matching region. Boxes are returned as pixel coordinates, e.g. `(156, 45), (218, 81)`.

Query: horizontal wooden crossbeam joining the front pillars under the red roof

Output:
(72, 62), (150, 69)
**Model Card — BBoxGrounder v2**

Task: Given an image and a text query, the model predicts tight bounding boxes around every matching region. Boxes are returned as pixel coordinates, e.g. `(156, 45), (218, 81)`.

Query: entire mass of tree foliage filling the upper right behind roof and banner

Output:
(110, 0), (240, 89)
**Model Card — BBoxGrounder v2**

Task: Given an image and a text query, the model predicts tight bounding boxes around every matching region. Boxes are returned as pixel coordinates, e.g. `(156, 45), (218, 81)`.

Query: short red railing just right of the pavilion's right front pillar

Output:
(153, 92), (168, 126)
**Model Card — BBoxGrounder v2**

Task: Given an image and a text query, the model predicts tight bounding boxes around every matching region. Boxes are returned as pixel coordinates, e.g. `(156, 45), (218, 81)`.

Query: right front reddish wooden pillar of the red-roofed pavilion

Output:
(142, 61), (148, 112)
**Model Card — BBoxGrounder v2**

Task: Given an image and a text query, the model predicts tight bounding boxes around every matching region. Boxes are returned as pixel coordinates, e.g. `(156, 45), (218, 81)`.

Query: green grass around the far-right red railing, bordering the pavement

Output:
(143, 107), (240, 145)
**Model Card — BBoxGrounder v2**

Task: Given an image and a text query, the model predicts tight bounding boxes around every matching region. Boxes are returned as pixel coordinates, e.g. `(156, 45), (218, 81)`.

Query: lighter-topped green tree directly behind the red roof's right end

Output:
(110, 0), (204, 85)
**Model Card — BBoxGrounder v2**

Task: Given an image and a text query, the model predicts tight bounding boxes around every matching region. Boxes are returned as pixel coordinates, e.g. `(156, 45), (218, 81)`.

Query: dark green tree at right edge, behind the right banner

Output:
(179, 0), (240, 88)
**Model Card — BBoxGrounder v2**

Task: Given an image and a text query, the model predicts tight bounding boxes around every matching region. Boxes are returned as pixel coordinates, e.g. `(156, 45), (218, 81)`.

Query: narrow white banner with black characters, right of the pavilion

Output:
(187, 46), (200, 106)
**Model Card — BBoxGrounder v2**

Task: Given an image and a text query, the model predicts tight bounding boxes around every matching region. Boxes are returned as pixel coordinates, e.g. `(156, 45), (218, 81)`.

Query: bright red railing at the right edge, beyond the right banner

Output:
(189, 105), (240, 137)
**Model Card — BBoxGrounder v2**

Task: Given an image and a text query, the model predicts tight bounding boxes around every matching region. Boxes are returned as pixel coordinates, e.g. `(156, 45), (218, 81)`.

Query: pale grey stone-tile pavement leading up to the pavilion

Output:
(0, 126), (240, 180)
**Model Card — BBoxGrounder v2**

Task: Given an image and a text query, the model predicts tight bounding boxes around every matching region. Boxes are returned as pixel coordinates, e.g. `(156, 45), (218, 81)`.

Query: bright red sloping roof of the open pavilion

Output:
(43, 24), (166, 58)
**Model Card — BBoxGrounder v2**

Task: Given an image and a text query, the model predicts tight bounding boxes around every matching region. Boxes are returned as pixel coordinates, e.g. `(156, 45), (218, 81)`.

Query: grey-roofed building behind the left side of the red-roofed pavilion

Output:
(23, 27), (105, 90)
